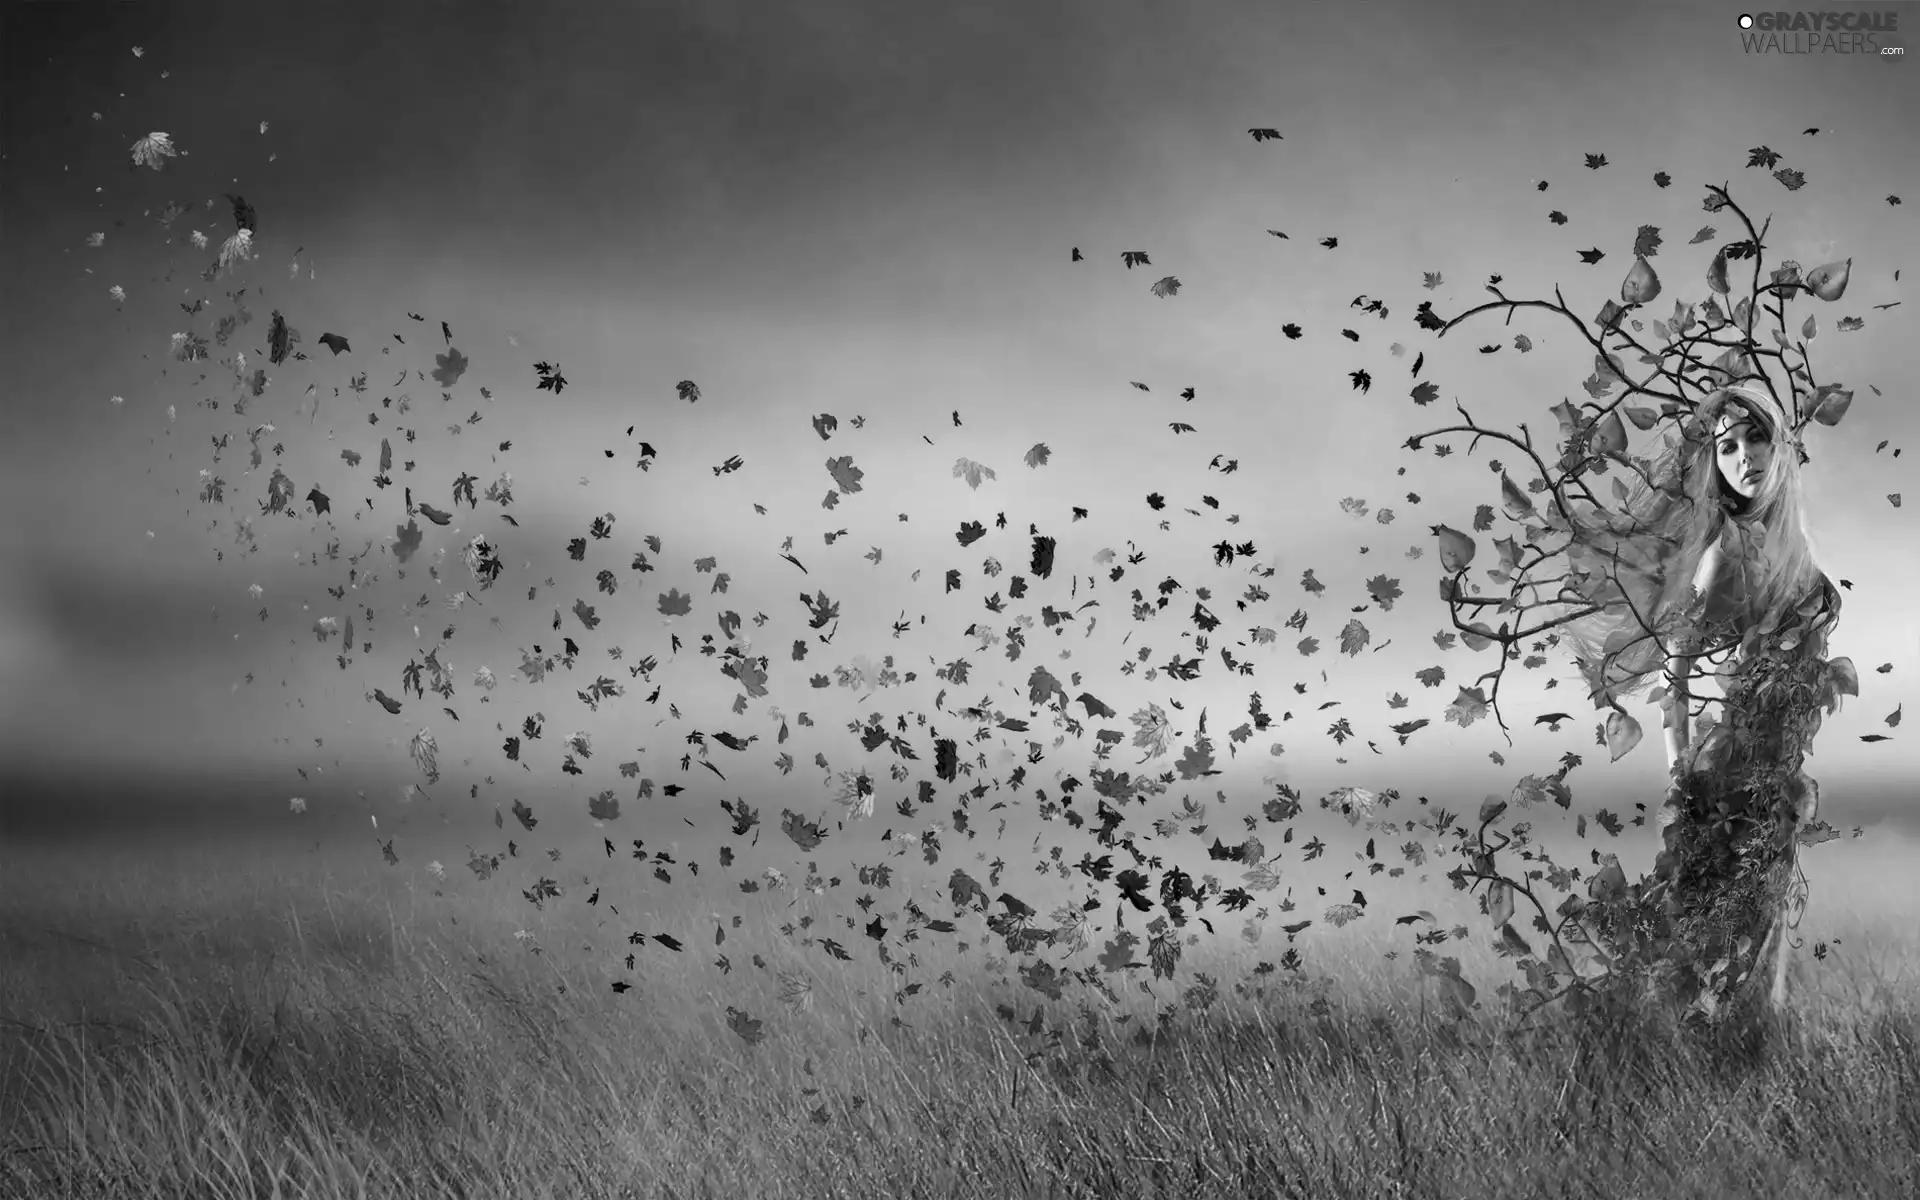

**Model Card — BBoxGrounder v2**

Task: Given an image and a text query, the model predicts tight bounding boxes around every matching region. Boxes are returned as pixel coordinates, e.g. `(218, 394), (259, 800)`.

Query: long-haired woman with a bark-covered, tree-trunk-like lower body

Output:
(1565, 384), (1839, 1021)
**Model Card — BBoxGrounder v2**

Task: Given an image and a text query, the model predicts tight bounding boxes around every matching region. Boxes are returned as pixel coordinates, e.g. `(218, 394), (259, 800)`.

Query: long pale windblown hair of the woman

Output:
(1561, 384), (1822, 708)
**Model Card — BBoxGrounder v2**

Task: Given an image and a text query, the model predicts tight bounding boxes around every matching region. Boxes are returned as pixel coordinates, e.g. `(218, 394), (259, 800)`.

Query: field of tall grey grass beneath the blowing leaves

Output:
(0, 821), (1920, 1200)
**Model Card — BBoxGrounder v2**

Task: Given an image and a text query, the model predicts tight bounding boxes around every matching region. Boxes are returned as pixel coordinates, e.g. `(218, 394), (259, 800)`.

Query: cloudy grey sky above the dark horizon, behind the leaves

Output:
(0, 0), (1920, 852)
